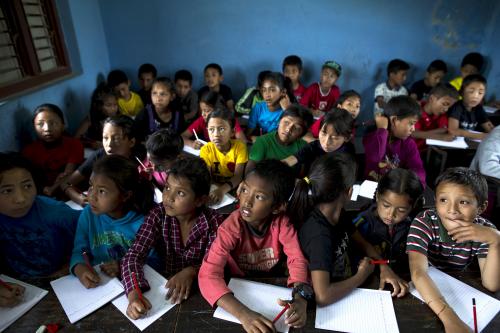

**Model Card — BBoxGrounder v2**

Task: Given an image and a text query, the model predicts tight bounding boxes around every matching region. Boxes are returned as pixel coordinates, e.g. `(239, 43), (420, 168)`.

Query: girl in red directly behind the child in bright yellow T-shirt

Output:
(182, 91), (247, 149)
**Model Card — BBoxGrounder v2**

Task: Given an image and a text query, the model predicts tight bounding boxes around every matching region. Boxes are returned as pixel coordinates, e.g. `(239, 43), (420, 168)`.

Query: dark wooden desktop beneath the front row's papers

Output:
(5, 272), (500, 333)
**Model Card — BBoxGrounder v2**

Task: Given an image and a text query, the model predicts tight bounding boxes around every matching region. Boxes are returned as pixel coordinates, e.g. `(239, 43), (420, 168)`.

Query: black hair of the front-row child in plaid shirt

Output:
(169, 156), (211, 198)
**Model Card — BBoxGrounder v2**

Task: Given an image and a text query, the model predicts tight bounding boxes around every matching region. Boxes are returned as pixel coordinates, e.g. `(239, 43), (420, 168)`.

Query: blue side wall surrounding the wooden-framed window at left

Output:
(0, 0), (110, 151)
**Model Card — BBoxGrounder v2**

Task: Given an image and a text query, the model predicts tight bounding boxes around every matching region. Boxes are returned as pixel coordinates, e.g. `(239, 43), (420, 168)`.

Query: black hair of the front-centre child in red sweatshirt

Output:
(245, 160), (295, 206)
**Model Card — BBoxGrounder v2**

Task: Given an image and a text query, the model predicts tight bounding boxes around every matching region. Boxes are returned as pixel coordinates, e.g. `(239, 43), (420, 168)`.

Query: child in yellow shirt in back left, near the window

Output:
(108, 69), (144, 118)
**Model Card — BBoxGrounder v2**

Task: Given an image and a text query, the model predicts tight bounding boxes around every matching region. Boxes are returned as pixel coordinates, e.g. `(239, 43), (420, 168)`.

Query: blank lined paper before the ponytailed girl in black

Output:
(314, 288), (399, 333)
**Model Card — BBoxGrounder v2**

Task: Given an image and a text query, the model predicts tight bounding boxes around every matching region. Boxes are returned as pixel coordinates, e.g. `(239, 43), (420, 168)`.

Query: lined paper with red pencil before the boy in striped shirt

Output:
(410, 266), (500, 332)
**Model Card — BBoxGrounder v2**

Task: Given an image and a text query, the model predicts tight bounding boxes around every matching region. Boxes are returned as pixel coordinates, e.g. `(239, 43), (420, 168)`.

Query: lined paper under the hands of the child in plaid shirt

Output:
(112, 265), (175, 331)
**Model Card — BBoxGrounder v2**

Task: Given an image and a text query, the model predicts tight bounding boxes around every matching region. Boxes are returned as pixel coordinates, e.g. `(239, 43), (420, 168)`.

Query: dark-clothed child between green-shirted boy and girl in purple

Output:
(283, 109), (354, 174)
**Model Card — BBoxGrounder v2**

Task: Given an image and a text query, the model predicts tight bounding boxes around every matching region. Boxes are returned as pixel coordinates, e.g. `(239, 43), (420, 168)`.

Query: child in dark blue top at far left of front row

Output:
(0, 153), (80, 277)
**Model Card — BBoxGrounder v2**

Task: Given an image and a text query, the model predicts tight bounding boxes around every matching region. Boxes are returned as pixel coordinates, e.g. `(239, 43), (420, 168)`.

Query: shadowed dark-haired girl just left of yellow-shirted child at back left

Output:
(75, 83), (118, 149)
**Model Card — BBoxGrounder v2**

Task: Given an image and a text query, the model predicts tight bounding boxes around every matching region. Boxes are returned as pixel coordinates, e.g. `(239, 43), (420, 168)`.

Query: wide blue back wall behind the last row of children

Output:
(100, 0), (500, 118)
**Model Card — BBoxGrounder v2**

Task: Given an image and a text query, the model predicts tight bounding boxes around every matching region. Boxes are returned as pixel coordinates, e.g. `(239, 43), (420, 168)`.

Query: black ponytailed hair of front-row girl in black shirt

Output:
(289, 152), (357, 227)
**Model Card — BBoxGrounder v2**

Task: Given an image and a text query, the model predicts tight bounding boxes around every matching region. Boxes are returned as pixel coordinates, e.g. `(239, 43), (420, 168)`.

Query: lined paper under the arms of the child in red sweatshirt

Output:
(214, 278), (292, 333)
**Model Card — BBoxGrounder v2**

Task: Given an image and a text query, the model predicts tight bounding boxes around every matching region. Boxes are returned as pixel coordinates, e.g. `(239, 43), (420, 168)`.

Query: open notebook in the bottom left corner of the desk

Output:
(0, 274), (48, 332)
